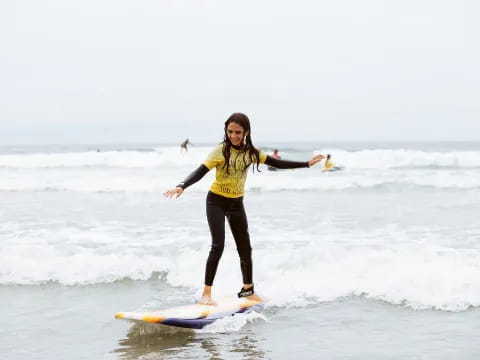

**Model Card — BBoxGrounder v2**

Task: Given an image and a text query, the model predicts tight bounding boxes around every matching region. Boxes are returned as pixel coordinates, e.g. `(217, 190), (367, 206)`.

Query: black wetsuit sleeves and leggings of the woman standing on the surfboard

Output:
(177, 156), (308, 286)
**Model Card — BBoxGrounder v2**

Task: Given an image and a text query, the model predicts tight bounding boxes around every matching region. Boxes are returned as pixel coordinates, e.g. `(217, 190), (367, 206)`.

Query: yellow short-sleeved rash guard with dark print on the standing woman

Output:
(203, 144), (267, 198)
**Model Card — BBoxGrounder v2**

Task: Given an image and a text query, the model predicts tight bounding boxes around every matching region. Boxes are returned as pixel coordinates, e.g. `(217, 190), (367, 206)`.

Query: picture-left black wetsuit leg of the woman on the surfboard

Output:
(205, 192), (226, 286)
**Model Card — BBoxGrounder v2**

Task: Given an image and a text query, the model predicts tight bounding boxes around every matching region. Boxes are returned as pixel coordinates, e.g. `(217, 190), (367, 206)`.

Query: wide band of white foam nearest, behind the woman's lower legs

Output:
(0, 221), (480, 310)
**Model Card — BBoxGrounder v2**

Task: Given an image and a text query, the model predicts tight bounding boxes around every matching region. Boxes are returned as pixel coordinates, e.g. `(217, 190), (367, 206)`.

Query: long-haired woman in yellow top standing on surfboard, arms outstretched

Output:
(164, 113), (324, 305)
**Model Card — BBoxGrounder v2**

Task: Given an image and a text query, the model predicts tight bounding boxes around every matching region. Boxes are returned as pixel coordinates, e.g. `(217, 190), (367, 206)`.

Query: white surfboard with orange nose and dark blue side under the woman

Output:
(115, 297), (263, 329)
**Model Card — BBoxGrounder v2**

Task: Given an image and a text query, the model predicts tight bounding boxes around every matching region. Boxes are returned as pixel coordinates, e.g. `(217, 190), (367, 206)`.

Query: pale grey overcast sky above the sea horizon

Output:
(0, 0), (480, 144)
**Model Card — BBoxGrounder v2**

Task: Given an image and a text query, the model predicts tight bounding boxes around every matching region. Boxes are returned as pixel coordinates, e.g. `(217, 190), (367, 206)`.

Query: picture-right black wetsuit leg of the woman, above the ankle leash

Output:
(227, 199), (252, 284)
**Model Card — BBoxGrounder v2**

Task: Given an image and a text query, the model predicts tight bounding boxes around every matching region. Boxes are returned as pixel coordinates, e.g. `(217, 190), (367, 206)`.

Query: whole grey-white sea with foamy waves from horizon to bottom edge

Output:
(0, 143), (480, 360)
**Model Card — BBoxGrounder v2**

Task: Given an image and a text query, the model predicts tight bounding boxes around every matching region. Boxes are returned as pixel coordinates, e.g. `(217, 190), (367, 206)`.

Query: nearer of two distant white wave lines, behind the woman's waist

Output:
(0, 167), (480, 193)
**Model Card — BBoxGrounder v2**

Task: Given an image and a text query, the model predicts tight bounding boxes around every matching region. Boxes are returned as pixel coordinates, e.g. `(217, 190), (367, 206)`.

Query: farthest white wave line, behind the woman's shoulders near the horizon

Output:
(0, 147), (480, 169)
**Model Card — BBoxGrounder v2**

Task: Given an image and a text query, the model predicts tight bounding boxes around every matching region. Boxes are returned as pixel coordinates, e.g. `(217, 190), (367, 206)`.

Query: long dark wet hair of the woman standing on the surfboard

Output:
(222, 113), (260, 174)
